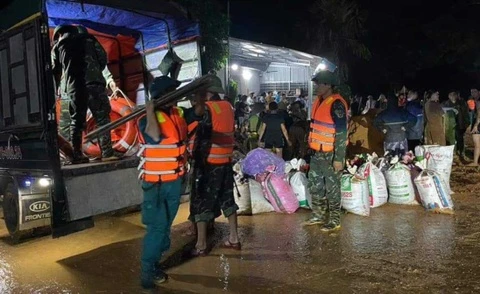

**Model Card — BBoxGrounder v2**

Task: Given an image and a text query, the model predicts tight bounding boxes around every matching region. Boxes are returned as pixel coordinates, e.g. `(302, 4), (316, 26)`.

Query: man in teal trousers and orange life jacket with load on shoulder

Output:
(138, 76), (205, 289)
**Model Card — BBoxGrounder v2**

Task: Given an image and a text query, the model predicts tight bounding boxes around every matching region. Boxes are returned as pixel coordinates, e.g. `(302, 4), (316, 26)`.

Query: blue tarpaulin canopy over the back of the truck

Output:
(46, 0), (200, 51)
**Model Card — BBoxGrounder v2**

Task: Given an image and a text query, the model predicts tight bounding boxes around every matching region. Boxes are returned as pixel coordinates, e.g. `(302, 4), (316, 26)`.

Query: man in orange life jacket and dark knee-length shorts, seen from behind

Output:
(190, 78), (241, 256)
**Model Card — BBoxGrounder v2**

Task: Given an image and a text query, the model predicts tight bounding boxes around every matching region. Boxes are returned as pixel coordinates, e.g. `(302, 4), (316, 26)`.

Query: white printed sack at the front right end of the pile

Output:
(415, 170), (453, 214)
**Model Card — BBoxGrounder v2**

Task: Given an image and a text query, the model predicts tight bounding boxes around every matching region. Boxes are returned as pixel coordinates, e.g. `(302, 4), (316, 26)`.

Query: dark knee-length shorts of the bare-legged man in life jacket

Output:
(190, 164), (238, 223)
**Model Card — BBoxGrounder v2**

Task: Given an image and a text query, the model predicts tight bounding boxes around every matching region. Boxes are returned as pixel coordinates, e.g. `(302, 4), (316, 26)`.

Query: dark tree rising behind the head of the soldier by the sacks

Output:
(302, 0), (371, 82)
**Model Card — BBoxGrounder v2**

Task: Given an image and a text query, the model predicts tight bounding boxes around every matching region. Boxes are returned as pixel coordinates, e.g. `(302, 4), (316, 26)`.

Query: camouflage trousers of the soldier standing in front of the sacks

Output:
(308, 152), (342, 224)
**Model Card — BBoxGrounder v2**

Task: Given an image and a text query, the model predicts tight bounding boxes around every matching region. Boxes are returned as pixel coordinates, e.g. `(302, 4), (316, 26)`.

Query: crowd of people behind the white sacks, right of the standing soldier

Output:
(350, 87), (480, 166)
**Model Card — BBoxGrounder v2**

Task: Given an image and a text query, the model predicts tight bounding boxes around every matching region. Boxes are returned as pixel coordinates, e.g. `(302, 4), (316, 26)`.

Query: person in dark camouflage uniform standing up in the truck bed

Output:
(52, 26), (119, 164)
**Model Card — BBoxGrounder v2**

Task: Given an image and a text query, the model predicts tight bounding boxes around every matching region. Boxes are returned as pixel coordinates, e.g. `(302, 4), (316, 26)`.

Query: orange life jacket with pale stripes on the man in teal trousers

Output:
(138, 107), (187, 183)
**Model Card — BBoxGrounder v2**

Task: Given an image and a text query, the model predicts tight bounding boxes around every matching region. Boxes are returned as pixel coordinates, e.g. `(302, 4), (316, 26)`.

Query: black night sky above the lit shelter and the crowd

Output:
(228, 0), (480, 98)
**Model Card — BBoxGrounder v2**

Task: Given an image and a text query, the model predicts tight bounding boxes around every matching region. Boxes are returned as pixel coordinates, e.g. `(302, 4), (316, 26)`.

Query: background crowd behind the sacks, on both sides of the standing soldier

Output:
(235, 82), (480, 166)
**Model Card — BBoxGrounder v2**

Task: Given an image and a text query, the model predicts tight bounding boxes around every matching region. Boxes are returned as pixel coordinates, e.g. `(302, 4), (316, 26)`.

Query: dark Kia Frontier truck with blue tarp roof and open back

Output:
(0, 0), (201, 240)
